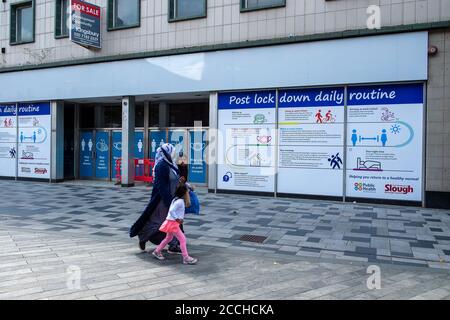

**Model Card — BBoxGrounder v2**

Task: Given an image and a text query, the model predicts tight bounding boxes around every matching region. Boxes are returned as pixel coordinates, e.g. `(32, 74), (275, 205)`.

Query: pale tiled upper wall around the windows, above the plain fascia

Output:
(0, 0), (450, 68)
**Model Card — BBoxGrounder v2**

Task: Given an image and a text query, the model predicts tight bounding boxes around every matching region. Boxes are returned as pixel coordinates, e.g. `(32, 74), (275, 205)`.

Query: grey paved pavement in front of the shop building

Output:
(0, 181), (450, 299)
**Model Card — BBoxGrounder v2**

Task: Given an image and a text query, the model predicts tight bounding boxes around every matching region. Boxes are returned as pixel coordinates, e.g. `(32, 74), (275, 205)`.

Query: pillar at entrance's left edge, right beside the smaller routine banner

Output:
(50, 101), (64, 182)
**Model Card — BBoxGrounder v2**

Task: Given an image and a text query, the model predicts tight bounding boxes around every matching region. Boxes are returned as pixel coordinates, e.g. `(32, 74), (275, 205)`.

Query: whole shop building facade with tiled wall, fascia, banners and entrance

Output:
(0, 0), (450, 207)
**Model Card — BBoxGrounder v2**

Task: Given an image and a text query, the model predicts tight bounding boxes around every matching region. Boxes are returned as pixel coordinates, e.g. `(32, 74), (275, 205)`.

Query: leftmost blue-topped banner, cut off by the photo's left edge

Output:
(0, 104), (17, 177)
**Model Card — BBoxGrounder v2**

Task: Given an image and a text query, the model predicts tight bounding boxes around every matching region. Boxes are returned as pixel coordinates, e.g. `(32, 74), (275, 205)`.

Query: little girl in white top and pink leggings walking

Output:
(152, 183), (197, 264)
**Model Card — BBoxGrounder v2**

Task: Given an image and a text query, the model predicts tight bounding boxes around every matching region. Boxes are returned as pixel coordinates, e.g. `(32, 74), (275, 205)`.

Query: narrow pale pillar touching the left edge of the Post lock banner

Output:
(206, 92), (218, 192)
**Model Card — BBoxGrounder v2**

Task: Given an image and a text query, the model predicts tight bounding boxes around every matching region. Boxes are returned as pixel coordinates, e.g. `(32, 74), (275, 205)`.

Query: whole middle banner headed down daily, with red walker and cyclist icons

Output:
(277, 87), (345, 197)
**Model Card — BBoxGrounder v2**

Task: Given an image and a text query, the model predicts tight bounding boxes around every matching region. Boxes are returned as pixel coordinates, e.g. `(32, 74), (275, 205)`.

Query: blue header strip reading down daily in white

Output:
(278, 88), (345, 108)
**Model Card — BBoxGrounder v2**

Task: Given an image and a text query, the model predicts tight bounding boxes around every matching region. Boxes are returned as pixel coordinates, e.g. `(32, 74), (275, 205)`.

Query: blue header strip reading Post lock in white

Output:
(218, 90), (276, 110)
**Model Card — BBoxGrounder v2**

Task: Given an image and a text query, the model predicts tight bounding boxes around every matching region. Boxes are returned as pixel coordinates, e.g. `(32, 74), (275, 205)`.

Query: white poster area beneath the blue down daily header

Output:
(277, 105), (345, 197)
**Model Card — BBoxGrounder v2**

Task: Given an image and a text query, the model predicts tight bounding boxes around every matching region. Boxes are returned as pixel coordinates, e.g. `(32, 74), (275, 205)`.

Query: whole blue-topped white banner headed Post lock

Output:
(217, 90), (276, 192)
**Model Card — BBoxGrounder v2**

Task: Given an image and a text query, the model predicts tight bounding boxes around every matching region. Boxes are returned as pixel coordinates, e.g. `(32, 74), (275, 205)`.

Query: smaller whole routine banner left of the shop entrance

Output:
(17, 102), (51, 179)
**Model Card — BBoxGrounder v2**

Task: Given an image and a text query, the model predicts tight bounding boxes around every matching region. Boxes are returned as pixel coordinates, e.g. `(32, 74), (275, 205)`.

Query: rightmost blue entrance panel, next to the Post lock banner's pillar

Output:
(188, 131), (206, 183)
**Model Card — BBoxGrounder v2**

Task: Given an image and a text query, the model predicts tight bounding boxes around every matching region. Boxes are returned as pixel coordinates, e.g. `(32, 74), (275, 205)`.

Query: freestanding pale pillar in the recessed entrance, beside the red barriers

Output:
(122, 97), (136, 187)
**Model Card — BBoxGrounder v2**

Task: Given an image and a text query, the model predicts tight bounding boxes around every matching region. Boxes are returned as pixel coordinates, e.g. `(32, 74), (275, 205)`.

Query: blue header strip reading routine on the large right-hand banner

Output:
(347, 83), (423, 106)
